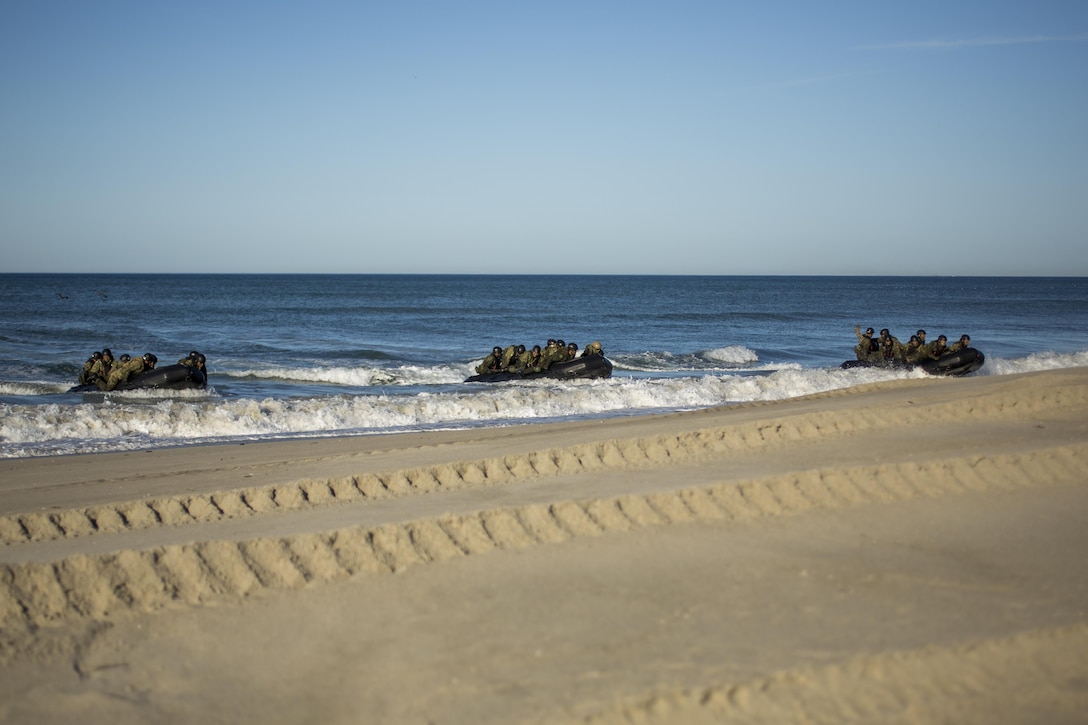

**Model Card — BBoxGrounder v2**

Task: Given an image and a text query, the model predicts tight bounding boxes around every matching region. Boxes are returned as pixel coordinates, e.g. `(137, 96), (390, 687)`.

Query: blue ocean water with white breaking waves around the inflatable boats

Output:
(0, 274), (1088, 457)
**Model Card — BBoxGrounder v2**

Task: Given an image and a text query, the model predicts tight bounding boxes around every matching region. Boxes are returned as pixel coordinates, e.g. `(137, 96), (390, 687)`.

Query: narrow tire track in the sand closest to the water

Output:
(0, 386), (1088, 544)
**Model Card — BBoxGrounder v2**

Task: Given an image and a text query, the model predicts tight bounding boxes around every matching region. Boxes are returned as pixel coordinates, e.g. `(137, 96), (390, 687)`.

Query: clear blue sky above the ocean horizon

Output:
(0, 0), (1088, 275)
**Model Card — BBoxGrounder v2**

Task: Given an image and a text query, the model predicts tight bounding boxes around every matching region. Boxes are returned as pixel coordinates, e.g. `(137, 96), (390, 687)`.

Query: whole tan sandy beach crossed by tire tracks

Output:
(0, 368), (1088, 723)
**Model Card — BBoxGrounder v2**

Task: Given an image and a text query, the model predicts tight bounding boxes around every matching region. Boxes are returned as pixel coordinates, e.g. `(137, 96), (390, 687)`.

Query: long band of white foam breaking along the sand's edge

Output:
(0, 352), (1088, 457)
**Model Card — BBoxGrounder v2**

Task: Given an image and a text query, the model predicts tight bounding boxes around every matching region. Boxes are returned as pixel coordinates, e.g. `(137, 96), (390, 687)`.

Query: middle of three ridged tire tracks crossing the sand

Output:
(0, 443), (1088, 640)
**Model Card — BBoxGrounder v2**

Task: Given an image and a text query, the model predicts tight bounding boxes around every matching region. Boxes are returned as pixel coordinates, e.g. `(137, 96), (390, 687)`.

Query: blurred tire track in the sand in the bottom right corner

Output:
(578, 624), (1088, 725)
